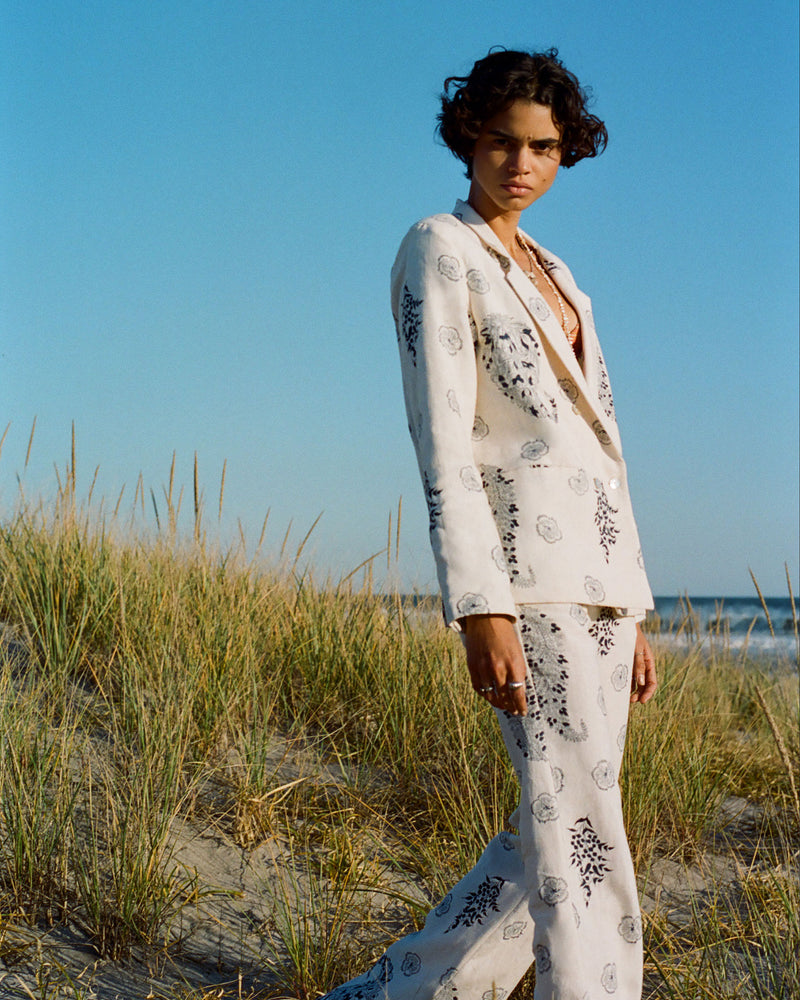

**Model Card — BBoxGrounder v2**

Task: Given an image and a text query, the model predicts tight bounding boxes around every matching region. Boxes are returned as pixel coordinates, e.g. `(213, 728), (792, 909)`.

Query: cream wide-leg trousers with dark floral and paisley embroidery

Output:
(325, 604), (642, 1000)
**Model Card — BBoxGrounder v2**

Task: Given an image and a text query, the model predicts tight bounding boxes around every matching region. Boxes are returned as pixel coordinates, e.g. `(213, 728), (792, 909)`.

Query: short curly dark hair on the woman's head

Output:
(436, 49), (608, 177)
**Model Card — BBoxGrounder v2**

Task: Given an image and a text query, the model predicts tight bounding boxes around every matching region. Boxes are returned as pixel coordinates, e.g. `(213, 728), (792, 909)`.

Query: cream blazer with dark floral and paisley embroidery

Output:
(392, 201), (653, 628)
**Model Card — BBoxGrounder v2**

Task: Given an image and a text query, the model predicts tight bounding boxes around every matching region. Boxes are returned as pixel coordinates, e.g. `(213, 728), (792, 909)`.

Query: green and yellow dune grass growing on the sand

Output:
(0, 444), (800, 1000)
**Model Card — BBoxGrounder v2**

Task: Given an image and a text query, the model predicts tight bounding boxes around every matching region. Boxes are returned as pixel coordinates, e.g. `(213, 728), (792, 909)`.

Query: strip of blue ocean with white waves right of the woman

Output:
(648, 595), (800, 663)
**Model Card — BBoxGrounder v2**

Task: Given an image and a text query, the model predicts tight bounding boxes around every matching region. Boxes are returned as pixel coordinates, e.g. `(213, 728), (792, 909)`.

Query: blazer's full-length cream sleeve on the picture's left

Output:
(392, 220), (516, 628)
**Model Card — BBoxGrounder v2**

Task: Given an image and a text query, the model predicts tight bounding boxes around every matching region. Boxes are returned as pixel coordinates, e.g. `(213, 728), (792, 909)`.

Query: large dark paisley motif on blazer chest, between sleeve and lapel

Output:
(479, 313), (558, 420)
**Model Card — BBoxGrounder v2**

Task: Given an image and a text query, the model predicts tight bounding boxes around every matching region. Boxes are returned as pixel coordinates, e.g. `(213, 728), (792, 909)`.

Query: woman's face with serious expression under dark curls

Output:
(469, 101), (561, 222)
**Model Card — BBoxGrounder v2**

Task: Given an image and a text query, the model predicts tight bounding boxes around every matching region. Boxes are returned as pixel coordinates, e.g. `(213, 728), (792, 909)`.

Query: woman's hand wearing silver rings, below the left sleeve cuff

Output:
(461, 615), (527, 715)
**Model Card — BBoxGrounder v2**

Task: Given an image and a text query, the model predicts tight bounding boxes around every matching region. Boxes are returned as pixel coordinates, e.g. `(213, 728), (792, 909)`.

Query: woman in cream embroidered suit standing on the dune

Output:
(329, 50), (656, 1000)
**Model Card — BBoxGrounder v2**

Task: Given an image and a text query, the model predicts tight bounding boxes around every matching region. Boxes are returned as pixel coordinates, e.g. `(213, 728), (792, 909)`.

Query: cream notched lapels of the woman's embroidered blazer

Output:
(453, 201), (621, 451)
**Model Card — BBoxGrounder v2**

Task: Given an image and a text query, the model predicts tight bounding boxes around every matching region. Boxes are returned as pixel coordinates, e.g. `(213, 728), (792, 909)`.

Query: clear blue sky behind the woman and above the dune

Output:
(0, 0), (798, 595)
